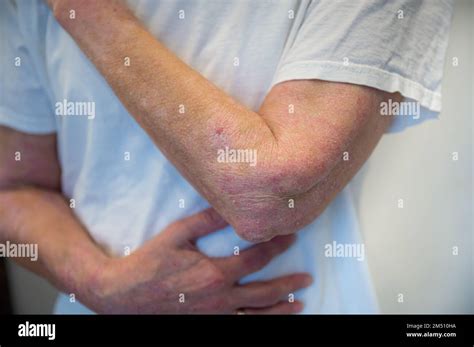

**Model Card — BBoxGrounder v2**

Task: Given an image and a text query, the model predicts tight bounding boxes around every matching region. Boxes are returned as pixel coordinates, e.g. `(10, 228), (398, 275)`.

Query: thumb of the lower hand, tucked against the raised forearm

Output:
(170, 208), (227, 241)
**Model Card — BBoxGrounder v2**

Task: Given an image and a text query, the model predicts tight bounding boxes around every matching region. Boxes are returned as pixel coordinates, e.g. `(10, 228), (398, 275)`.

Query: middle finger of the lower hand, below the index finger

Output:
(232, 274), (312, 308)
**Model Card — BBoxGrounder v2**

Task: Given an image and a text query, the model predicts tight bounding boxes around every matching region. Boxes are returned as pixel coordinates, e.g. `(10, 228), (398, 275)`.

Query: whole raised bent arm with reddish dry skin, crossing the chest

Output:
(52, 0), (400, 242)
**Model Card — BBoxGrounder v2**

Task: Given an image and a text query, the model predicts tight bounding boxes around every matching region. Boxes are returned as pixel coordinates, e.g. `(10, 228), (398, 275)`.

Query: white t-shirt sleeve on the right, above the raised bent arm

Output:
(272, 0), (453, 131)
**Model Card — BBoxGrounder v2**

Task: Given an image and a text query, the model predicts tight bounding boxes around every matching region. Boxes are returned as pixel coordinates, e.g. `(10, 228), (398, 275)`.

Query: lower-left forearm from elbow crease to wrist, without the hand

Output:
(0, 187), (106, 304)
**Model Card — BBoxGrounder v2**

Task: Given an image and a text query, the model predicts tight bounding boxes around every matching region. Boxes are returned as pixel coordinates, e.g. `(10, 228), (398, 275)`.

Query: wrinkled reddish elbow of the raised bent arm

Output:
(218, 154), (325, 242)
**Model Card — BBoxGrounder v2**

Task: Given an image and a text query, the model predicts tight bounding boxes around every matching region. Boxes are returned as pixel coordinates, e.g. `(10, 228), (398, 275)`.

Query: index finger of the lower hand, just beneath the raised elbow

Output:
(216, 235), (296, 282)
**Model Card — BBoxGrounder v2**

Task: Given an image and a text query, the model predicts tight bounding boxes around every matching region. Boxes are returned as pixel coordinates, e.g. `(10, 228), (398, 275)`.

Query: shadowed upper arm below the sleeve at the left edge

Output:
(0, 126), (61, 191)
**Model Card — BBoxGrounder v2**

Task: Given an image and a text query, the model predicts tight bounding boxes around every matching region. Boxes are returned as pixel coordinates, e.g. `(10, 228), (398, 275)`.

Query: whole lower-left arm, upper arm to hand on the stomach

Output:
(0, 127), (311, 313)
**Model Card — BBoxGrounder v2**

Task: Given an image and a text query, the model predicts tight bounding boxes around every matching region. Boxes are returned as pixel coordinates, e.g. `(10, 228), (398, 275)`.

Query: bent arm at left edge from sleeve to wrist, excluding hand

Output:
(0, 127), (106, 302)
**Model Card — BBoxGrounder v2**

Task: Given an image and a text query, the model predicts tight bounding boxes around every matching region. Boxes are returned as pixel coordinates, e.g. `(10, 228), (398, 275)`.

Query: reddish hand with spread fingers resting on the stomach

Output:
(85, 209), (311, 314)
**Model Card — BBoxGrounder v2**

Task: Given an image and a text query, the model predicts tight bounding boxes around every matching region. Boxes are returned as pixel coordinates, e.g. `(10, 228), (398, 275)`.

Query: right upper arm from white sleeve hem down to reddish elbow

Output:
(236, 80), (401, 241)
